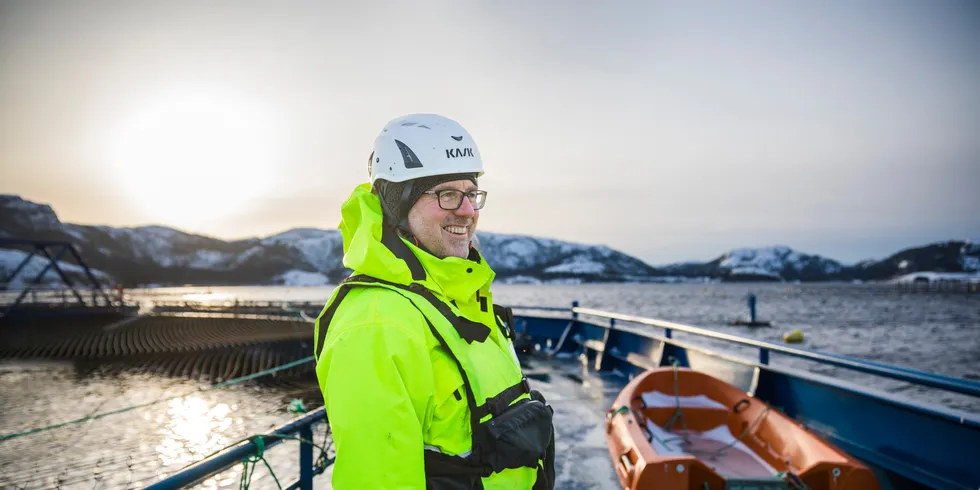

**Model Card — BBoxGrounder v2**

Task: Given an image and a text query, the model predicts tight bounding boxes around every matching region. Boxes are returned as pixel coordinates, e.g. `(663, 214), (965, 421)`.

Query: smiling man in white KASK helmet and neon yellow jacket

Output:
(315, 114), (554, 490)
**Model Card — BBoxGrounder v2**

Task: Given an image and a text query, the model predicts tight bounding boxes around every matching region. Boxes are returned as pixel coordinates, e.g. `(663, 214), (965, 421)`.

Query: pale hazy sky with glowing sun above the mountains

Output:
(0, 0), (980, 265)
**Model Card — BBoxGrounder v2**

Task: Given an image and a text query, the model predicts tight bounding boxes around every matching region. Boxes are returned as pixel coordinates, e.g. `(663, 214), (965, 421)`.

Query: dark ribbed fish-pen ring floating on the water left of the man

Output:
(0, 308), (315, 382)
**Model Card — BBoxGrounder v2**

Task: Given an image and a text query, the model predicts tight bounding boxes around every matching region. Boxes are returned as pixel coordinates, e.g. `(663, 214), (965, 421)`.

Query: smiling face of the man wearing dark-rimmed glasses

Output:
(408, 179), (480, 259)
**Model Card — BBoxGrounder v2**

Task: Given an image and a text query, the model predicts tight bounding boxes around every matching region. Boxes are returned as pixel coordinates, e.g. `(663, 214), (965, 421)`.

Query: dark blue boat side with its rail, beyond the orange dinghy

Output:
(516, 308), (980, 490)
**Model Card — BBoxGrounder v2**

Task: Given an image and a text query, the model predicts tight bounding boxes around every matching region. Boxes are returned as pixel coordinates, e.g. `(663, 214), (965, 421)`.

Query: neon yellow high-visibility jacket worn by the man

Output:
(315, 184), (537, 490)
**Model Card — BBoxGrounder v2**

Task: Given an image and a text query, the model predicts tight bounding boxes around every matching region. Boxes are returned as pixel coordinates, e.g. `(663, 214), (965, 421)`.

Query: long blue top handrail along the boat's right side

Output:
(572, 307), (980, 397)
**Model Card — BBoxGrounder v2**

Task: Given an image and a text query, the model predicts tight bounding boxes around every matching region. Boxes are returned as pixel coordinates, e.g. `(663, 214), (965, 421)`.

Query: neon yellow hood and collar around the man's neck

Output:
(340, 183), (495, 301)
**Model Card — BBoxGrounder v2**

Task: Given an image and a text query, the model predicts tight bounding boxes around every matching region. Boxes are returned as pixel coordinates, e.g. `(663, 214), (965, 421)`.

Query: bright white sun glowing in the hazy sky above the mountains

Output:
(109, 93), (280, 232)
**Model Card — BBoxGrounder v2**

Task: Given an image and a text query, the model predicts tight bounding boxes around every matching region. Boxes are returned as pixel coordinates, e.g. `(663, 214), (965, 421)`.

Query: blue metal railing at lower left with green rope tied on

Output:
(146, 408), (333, 490)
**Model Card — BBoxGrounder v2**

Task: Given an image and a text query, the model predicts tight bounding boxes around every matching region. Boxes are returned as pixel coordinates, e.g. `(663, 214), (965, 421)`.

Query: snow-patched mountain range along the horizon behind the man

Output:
(0, 195), (980, 287)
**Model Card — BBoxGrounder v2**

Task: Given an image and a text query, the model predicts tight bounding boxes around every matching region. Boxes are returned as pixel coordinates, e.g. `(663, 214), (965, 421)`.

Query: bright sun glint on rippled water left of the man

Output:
(156, 395), (235, 467)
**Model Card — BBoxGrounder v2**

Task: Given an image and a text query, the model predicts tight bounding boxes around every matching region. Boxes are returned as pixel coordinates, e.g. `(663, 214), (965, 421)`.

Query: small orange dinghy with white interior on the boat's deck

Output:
(606, 367), (880, 490)
